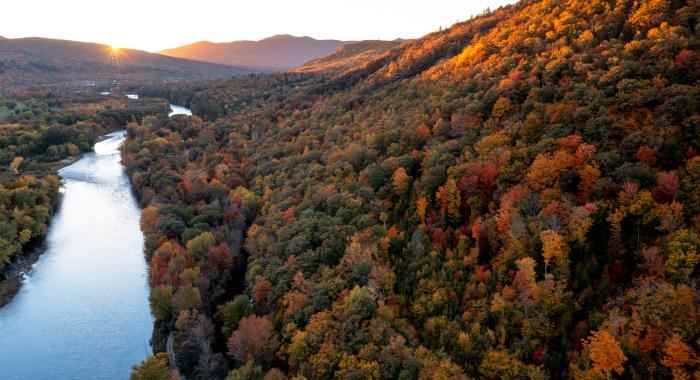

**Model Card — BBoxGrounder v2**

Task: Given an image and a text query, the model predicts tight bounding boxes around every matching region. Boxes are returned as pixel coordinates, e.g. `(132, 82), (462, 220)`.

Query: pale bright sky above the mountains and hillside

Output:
(0, 0), (514, 51)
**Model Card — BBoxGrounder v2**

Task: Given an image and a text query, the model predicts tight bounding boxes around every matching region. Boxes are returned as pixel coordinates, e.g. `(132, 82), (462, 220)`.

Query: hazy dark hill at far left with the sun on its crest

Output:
(0, 38), (247, 85)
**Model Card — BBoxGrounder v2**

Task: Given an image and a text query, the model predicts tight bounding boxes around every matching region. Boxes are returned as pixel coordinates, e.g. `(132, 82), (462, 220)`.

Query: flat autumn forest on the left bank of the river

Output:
(0, 91), (168, 276)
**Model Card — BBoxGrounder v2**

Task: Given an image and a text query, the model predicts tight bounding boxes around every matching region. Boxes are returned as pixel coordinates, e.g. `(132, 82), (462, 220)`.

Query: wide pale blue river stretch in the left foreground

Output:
(0, 131), (153, 380)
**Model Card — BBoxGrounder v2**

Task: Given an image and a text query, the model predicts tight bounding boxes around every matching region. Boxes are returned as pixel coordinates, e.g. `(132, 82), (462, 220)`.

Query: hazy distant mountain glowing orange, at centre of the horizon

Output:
(160, 35), (346, 70)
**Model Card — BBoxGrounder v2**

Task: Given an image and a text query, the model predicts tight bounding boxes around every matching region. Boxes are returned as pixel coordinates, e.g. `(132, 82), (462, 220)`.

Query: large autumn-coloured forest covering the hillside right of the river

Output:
(122, 0), (700, 380)
